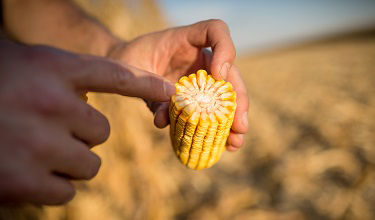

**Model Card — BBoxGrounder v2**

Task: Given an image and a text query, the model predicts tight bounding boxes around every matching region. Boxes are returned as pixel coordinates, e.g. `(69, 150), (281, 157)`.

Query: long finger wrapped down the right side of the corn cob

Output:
(227, 65), (249, 134)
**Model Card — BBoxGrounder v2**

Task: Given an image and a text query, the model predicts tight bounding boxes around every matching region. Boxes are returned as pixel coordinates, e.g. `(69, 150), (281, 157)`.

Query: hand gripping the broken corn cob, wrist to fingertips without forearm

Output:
(108, 20), (249, 151)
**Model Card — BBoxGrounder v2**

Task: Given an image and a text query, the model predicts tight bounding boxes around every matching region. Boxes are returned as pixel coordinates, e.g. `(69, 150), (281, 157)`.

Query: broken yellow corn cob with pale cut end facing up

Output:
(169, 70), (236, 170)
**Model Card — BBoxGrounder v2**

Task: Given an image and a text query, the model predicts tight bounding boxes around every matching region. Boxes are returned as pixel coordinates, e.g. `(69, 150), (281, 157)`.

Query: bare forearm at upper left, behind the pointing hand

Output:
(3, 0), (119, 56)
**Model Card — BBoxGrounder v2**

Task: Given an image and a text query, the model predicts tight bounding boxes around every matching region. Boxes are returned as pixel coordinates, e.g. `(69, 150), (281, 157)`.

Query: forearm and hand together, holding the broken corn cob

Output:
(3, 0), (248, 151)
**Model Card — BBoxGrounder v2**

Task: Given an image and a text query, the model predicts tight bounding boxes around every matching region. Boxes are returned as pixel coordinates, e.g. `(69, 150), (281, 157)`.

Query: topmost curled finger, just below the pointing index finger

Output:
(61, 97), (110, 147)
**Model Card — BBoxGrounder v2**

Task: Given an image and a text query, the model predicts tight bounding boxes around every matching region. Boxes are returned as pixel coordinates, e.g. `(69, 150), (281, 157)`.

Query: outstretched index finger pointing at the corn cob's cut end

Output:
(70, 56), (176, 101)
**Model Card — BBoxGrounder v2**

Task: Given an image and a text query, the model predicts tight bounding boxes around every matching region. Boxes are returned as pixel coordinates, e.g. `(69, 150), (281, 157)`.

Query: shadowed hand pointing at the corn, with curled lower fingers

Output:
(0, 40), (175, 205)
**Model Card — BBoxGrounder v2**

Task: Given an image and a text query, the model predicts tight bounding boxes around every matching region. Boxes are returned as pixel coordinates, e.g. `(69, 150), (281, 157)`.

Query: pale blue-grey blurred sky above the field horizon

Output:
(158, 0), (375, 53)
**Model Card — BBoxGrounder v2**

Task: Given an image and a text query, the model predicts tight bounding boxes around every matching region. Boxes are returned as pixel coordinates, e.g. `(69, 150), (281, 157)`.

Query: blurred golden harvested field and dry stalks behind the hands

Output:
(0, 0), (375, 220)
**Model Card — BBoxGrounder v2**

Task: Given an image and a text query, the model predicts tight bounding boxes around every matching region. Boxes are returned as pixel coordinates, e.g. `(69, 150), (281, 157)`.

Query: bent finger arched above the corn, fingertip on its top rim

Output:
(188, 19), (236, 79)
